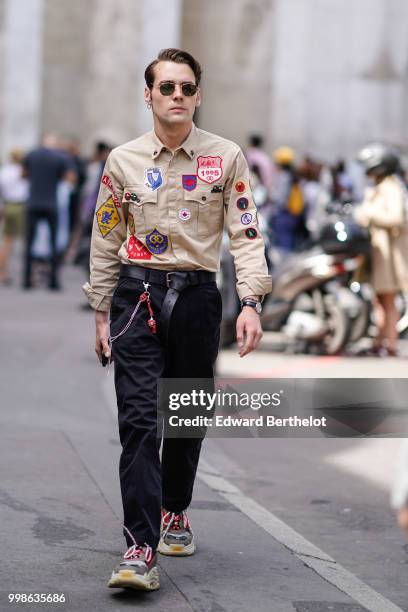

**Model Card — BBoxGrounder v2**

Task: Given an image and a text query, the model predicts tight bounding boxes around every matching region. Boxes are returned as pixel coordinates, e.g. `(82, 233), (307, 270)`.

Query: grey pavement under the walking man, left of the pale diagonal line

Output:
(0, 268), (397, 612)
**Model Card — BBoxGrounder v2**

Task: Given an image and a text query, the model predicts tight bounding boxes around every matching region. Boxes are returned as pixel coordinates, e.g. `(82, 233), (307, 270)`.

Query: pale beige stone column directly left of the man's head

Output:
(84, 0), (181, 152)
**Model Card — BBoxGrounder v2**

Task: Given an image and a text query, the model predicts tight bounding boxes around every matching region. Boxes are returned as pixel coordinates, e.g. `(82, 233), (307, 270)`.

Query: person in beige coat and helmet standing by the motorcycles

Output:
(354, 144), (408, 356)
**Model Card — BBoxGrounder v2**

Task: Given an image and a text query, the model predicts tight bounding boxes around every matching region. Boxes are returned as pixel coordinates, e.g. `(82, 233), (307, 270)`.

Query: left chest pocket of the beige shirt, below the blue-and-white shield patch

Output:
(122, 185), (160, 237)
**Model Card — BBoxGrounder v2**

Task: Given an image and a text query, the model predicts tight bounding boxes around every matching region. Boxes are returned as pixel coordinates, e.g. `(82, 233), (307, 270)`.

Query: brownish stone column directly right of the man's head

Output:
(182, 0), (275, 151)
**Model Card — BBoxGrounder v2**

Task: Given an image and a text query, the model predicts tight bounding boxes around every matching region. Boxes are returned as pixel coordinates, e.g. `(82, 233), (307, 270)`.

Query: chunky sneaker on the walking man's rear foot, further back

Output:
(157, 509), (195, 557)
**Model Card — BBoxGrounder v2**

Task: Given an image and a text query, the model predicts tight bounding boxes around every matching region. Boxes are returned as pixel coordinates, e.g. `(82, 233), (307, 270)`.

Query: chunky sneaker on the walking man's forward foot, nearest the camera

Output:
(108, 545), (160, 591)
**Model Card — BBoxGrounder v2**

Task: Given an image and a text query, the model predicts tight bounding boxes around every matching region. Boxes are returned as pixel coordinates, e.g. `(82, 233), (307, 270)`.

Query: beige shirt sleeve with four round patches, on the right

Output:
(224, 148), (272, 299)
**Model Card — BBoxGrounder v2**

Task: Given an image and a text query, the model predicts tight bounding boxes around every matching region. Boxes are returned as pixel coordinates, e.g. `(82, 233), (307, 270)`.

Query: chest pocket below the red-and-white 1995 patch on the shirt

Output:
(184, 187), (224, 238)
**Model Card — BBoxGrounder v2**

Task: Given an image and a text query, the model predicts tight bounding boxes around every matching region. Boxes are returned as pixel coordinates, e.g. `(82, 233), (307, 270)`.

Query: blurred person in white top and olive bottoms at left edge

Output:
(0, 149), (28, 284)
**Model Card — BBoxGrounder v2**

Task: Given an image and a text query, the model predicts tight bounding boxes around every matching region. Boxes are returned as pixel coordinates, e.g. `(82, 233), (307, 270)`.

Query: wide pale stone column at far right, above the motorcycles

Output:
(271, 0), (408, 161)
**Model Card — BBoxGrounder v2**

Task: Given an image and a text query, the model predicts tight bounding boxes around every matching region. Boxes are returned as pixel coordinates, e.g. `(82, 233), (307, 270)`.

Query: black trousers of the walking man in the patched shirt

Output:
(111, 278), (222, 550)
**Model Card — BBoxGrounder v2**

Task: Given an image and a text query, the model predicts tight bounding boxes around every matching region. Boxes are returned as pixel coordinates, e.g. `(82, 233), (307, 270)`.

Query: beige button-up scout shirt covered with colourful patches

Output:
(84, 124), (272, 311)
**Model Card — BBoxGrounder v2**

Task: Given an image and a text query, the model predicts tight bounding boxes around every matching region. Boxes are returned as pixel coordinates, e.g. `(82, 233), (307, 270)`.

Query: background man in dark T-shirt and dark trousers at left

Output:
(23, 134), (76, 290)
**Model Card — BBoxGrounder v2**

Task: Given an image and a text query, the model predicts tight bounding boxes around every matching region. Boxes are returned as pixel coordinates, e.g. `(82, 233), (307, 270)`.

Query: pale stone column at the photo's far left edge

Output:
(0, 0), (43, 158)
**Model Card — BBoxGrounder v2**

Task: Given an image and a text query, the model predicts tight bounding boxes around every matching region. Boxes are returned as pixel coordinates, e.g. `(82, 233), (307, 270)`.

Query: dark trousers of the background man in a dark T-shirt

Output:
(23, 209), (58, 288)
